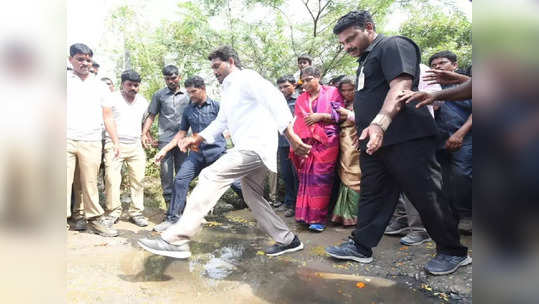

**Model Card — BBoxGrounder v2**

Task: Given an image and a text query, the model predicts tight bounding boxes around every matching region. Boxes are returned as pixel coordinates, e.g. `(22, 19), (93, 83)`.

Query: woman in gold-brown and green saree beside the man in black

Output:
(331, 77), (361, 226)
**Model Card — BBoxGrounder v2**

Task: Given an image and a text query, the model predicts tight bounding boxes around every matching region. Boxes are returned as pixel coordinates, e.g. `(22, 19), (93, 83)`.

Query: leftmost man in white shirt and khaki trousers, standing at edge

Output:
(66, 43), (118, 236)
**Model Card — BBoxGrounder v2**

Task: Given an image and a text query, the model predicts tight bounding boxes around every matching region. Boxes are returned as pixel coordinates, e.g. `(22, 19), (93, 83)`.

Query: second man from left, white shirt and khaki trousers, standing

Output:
(103, 70), (148, 227)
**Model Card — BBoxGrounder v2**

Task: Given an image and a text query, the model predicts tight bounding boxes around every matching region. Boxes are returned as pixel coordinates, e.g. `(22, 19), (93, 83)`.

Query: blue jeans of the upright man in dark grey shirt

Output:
(159, 142), (187, 204)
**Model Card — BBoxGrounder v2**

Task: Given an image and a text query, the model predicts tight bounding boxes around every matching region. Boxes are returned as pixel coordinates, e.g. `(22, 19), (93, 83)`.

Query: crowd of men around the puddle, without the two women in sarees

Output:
(66, 11), (472, 275)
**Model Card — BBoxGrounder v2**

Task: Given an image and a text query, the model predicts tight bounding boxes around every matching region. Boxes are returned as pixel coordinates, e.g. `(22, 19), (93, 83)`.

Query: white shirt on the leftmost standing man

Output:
(66, 72), (110, 141)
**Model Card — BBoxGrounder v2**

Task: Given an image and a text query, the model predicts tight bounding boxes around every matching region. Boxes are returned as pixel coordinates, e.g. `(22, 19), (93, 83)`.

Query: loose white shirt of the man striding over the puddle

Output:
(199, 70), (292, 172)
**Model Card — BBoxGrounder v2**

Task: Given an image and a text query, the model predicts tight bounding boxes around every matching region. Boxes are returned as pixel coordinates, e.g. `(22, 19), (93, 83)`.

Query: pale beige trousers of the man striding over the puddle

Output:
(161, 150), (294, 245)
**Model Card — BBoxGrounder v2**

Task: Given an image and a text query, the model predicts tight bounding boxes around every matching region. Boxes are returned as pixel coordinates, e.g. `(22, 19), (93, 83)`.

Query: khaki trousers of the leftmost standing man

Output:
(66, 139), (104, 218)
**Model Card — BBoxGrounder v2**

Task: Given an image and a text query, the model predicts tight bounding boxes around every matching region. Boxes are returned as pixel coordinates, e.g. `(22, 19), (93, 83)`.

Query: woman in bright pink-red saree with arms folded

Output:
(290, 66), (342, 232)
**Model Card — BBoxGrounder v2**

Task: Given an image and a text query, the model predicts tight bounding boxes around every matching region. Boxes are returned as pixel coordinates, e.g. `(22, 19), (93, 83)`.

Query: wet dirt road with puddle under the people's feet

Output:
(66, 209), (472, 304)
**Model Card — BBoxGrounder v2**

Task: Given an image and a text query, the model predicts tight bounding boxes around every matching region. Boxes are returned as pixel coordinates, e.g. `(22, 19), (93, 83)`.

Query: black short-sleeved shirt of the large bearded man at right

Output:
(354, 34), (437, 149)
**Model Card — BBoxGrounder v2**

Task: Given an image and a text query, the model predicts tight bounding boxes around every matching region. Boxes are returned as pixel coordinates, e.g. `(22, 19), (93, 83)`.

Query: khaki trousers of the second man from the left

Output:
(105, 141), (146, 217)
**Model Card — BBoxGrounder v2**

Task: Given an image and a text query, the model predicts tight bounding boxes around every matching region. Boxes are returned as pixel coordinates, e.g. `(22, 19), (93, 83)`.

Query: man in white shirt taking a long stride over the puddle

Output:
(138, 46), (311, 259)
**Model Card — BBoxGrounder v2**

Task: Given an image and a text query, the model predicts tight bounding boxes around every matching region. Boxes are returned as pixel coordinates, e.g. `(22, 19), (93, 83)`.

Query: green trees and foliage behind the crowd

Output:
(104, 0), (472, 185)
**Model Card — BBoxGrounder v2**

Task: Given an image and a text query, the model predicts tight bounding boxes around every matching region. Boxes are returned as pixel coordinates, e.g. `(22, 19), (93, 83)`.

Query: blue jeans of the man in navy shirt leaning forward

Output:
(166, 153), (243, 223)
